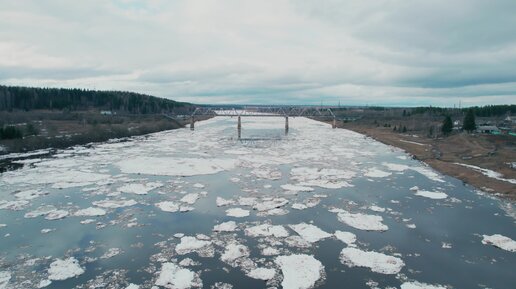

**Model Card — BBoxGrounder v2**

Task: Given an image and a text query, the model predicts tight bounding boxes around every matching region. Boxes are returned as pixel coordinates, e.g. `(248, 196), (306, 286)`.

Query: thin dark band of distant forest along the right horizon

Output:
(411, 104), (516, 117)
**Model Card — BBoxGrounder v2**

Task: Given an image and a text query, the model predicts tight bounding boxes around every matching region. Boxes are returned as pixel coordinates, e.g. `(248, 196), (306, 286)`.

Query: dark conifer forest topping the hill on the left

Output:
(0, 85), (190, 114)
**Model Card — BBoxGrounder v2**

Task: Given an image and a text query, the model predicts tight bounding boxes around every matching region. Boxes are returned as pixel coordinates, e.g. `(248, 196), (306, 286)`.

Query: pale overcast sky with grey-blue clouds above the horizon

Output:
(0, 0), (516, 106)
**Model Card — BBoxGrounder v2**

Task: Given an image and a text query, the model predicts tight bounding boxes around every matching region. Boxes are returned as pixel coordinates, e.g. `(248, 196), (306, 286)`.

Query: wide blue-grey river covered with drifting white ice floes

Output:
(0, 117), (516, 289)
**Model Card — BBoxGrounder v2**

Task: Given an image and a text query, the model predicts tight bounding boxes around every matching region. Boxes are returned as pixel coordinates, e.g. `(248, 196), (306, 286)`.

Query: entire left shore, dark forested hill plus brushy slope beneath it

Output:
(0, 85), (195, 160)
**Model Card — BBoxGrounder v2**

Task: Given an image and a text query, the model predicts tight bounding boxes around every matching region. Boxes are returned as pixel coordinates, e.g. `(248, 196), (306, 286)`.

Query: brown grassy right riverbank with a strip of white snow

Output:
(326, 118), (516, 200)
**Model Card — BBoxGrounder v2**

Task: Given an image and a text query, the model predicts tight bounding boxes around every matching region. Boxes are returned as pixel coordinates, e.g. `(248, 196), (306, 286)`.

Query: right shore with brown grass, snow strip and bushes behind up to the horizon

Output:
(314, 110), (516, 201)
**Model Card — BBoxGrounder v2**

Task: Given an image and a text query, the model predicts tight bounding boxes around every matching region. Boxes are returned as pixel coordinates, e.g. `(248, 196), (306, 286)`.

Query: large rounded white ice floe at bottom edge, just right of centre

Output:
(274, 254), (324, 289)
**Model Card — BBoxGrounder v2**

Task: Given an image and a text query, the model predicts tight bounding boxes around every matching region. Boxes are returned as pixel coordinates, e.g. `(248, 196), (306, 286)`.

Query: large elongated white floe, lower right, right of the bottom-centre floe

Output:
(340, 247), (405, 274)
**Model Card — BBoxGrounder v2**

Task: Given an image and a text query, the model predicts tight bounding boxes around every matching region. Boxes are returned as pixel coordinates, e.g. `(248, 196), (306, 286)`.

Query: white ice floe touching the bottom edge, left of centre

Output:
(155, 262), (202, 289)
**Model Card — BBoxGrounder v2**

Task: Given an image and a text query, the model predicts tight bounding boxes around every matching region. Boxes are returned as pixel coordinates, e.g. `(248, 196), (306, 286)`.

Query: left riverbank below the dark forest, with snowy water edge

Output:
(0, 112), (212, 172)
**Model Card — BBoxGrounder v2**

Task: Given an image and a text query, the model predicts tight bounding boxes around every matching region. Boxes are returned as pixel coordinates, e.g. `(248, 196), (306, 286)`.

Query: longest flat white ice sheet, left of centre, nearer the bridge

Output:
(116, 157), (236, 176)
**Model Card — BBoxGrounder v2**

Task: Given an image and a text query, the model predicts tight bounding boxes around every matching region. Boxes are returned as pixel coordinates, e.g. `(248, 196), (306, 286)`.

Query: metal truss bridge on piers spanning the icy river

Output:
(165, 106), (337, 139)
